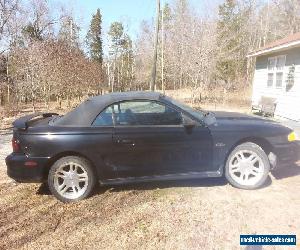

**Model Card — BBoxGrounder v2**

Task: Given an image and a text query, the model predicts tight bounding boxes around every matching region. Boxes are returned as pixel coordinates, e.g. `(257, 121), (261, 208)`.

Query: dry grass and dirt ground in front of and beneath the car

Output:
(0, 130), (300, 249)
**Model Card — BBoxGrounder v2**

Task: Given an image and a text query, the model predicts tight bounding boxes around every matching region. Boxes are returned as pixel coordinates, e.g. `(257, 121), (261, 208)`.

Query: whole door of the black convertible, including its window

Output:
(110, 100), (212, 178)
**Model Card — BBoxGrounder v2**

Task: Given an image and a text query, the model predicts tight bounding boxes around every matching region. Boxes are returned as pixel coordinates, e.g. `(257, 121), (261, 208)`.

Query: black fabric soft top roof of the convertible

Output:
(53, 91), (163, 126)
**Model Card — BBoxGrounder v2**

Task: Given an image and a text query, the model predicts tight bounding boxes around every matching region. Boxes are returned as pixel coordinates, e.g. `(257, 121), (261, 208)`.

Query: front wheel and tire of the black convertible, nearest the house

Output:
(225, 142), (270, 189)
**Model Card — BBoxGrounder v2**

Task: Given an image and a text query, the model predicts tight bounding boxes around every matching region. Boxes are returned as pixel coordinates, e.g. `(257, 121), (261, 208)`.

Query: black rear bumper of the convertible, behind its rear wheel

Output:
(5, 153), (49, 182)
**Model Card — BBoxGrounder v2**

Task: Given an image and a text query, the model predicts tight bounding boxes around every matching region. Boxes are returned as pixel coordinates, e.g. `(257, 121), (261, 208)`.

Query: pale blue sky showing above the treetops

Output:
(49, 0), (221, 50)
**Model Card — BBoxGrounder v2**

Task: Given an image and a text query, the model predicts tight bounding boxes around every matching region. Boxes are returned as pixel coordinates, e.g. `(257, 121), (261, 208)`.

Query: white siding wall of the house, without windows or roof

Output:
(252, 48), (300, 121)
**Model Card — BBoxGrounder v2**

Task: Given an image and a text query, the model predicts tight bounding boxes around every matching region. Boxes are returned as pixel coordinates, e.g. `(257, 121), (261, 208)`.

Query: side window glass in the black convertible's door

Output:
(114, 101), (182, 126)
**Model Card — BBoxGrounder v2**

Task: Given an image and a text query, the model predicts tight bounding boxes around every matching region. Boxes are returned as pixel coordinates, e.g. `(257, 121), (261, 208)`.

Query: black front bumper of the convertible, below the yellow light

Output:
(274, 141), (300, 168)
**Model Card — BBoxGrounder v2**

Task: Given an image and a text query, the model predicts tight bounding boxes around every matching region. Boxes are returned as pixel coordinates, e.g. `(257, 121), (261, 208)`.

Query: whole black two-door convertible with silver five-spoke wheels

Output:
(6, 92), (299, 202)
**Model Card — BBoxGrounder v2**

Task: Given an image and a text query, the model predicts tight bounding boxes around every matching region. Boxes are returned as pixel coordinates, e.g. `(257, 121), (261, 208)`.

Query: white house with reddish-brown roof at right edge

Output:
(248, 33), (300, 121)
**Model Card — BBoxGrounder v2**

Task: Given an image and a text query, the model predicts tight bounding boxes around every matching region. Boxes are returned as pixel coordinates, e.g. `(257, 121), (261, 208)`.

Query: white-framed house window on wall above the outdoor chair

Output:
(267, 56), (286, 88)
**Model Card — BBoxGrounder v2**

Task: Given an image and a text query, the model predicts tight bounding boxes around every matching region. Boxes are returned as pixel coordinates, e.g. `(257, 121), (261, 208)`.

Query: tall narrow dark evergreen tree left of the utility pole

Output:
(87, 9), (103, 64)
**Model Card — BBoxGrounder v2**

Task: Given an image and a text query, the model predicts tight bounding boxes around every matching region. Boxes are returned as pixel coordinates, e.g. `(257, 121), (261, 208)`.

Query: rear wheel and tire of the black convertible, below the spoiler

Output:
(48, 156), (96, 203)
